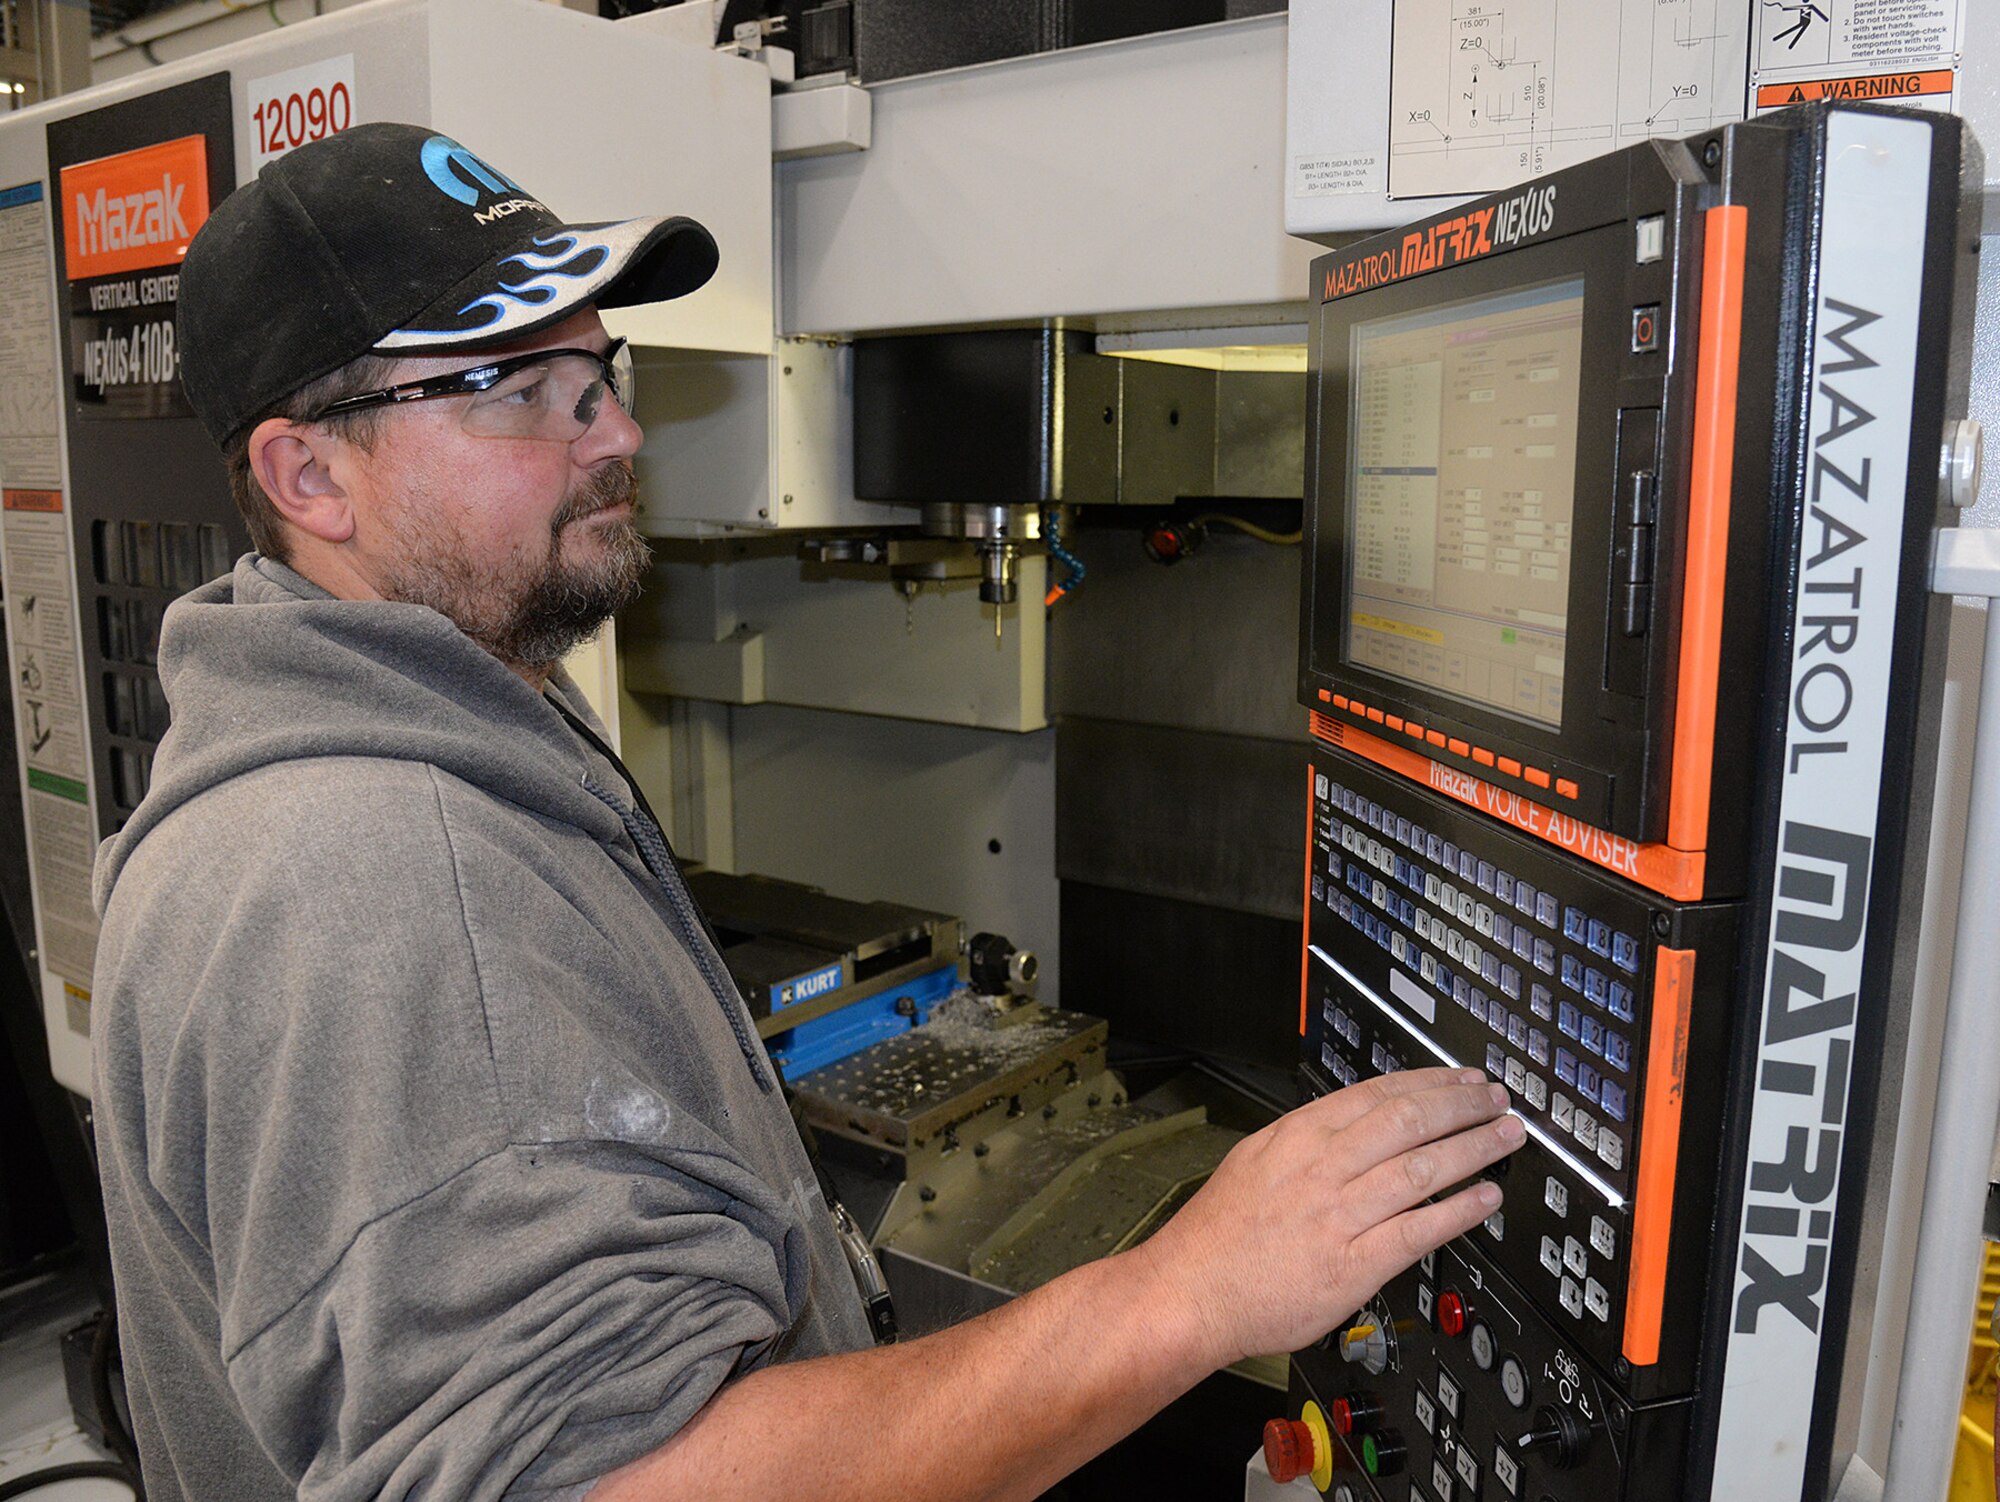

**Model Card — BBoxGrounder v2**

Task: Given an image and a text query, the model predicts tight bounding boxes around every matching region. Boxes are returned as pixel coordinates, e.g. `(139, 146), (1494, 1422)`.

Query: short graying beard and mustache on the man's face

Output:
(384, 464), (652, 676)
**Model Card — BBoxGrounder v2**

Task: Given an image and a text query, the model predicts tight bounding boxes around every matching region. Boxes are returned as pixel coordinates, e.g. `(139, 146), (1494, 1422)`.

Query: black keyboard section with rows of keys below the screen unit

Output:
(1302, 752), (1728, 1392)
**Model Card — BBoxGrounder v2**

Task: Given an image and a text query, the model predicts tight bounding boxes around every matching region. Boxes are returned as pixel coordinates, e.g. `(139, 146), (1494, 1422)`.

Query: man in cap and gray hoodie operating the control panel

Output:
(96, 124), (1522, 1502)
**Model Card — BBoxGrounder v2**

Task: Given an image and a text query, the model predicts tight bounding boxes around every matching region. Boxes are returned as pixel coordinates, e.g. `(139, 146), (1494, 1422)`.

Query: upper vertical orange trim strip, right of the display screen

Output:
(1666, 204), (1750, 850)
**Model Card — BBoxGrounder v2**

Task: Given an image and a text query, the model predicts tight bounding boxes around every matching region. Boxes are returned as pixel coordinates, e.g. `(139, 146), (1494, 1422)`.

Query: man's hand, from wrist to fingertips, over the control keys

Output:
(1132, 1070), (1526, 1366)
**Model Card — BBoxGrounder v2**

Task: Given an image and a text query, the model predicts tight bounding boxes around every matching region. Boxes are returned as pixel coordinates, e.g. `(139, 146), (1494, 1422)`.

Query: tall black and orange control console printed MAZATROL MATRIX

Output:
(1266, 108), (1980, 1502)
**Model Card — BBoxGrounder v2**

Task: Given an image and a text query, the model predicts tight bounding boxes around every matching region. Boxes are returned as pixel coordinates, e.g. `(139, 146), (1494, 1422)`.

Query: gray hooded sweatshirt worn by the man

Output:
(94, 554), (868, 1502)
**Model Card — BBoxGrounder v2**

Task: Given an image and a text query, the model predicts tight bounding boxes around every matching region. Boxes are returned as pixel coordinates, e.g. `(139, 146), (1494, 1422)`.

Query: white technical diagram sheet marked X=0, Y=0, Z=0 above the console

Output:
(1388, 0), (1750, 198)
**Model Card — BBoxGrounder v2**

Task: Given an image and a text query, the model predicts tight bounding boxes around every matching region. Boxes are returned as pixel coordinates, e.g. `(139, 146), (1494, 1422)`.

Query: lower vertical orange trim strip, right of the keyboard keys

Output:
(1622, 950), (1694, 1366)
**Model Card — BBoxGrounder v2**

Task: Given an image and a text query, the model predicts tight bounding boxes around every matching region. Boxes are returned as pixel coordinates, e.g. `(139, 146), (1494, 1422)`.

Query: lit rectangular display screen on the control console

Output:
(1344, 278), (1584, 728)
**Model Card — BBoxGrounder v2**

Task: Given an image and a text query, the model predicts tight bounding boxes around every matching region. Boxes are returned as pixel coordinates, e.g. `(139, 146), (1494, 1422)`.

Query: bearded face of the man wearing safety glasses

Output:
(332, 310), (650, 670)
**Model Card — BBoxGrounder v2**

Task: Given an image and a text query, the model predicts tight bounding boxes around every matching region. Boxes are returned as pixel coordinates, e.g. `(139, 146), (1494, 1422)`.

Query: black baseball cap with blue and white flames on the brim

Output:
(176, 122), (716, 444)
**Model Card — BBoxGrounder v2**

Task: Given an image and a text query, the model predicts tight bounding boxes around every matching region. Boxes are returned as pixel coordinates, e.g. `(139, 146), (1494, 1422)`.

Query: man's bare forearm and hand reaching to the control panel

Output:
(590, 1070), (1522, 1502)
